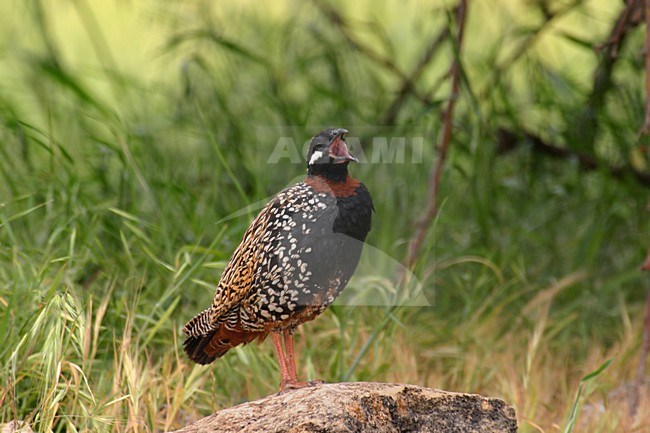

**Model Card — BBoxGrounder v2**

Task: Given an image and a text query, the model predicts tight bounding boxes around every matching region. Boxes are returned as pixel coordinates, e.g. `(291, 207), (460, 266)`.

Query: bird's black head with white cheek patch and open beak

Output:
(307, 128), (359, 181)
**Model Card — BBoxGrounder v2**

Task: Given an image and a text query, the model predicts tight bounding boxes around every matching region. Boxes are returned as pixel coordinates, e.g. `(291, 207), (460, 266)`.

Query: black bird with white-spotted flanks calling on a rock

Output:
(183, 128), (374, 393)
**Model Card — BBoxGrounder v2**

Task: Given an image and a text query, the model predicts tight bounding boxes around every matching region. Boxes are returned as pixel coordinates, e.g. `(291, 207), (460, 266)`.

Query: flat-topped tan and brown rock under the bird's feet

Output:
(172, 382), (517, 433)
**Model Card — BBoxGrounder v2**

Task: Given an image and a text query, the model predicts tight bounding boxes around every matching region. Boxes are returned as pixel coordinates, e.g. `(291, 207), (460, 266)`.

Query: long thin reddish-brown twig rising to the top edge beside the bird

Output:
(406, 0), (467, 269)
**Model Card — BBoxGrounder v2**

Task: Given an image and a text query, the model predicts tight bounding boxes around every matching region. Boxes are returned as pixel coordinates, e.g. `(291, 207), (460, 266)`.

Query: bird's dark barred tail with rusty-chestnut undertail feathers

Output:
(183, 310), (265, 365)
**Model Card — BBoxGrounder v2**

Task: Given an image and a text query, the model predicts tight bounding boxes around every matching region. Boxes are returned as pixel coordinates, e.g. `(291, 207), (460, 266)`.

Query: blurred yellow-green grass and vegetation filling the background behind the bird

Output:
(0, 0), (650, 432)
